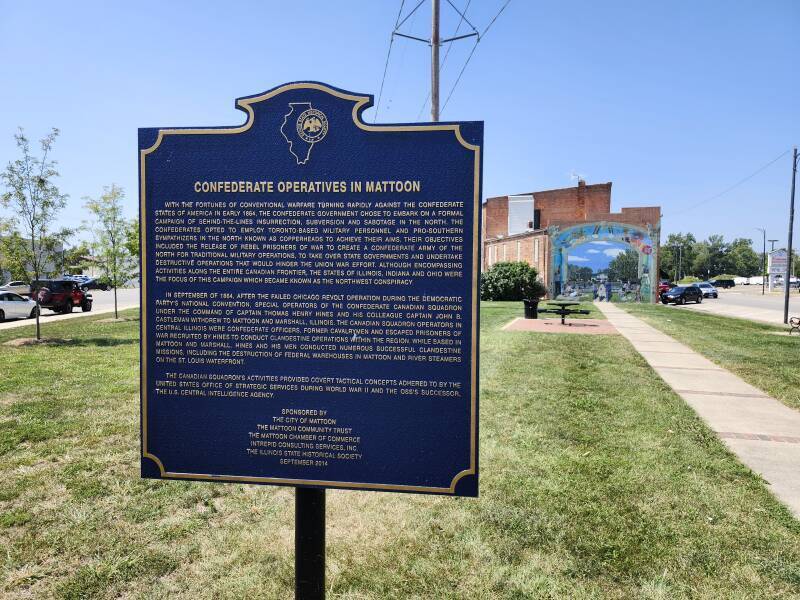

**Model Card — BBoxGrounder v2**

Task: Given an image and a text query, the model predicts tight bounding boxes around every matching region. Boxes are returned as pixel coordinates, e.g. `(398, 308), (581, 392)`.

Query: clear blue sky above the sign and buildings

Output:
(0, 0), (800, 243)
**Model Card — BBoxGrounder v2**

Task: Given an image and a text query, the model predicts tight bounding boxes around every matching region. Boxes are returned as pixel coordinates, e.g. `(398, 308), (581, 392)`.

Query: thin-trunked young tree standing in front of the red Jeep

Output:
(0, 128), (70, 340)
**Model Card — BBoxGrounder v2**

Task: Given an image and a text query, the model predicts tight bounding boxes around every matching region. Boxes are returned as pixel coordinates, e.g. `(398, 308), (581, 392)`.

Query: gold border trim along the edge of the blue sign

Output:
(139, 83), (481, 494)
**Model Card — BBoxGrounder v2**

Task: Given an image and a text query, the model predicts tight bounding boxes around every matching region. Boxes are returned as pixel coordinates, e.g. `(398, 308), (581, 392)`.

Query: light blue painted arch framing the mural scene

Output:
(547, 221), (659, 302)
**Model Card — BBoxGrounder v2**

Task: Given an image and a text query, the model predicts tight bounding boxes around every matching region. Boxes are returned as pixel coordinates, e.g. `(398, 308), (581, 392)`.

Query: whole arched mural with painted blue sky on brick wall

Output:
(548, 222), (658, 302)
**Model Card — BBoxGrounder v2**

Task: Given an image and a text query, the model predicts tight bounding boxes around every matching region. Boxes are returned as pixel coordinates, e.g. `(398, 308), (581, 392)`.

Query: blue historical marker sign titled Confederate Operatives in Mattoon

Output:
(139, 82), (483, 496)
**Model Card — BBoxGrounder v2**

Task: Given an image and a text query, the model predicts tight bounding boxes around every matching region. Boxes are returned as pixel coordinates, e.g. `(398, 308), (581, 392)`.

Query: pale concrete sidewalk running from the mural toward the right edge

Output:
(596, 302), (800, 518)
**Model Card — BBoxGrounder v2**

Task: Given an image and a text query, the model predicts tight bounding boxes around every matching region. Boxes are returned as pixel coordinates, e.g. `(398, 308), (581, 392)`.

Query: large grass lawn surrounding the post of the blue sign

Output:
(0, 303), (800, 599)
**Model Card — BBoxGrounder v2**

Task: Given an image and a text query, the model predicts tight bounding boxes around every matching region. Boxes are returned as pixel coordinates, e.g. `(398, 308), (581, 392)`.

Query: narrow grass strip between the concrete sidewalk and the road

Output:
(619, 300), (800, 409)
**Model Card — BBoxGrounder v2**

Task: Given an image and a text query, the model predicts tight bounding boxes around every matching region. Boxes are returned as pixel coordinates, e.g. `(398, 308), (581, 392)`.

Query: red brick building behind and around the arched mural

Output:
(481, 180), (661, 298)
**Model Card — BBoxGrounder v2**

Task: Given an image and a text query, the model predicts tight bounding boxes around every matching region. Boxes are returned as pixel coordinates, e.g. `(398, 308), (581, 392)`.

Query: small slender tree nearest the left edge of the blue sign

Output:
(84, 184), (133, 319)
